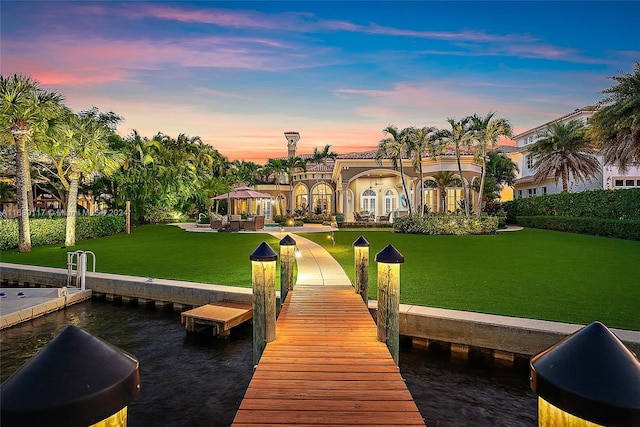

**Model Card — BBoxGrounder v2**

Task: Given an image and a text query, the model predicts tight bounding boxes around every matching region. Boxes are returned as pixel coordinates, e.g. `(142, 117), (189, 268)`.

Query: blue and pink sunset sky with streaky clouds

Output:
(0, 0), (640, 163)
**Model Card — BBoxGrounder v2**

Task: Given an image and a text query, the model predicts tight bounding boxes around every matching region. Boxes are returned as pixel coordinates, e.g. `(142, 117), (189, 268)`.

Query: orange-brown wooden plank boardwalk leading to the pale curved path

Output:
(233, 285), (425, 427)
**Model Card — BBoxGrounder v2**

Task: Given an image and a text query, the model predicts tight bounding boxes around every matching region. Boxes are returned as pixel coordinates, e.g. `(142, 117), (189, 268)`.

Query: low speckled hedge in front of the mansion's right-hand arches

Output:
(393, 214), (498, 236)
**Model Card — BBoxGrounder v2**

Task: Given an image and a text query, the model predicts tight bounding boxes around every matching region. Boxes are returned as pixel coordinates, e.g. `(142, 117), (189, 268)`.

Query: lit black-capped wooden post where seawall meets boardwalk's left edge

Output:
(249, 242), (278, 366)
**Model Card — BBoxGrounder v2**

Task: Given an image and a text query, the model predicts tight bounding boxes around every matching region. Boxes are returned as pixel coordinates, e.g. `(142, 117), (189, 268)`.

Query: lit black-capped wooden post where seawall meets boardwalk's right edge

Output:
(376, 245), (404, 365)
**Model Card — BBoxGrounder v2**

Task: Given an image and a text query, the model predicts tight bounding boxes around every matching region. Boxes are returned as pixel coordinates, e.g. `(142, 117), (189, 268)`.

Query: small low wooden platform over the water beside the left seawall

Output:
(180, 301), (253, 337)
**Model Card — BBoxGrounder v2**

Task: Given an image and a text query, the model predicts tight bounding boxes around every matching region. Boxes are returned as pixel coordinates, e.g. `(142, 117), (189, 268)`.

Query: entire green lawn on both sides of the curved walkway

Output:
(0, 226), (640, 330)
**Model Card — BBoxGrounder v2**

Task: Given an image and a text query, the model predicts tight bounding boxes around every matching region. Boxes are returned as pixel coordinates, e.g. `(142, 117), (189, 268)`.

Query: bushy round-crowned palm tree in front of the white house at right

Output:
(529, 120), (601, 193)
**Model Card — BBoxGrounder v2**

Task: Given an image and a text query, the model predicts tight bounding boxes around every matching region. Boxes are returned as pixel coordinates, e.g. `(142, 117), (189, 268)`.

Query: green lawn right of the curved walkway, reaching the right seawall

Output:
(304, 229), (640, 330)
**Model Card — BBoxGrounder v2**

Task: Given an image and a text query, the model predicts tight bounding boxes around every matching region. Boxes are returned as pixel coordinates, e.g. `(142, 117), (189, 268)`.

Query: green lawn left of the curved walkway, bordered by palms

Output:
(0, 225), (279, 288)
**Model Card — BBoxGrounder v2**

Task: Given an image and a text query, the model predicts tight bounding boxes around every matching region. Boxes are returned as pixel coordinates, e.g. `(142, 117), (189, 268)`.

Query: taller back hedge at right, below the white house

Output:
(503, 188), (640, 222)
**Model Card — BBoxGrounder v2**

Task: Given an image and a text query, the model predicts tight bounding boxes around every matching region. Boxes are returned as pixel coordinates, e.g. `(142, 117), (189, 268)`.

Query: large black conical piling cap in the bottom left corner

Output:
(0, 326), (140, 427)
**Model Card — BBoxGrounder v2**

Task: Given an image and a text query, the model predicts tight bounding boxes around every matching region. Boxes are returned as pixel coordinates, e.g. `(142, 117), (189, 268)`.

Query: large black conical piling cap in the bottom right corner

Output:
(531, 322), (640, 426)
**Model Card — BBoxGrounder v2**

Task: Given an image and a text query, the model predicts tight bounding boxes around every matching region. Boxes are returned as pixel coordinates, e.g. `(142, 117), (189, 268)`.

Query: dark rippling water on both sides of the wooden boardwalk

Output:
(0, 301), (537, 427)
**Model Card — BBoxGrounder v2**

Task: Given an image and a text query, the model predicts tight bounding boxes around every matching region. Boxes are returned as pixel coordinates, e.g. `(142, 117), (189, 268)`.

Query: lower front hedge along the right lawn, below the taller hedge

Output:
(518, 216), (640, 240)
